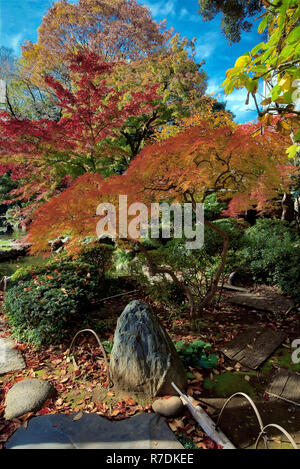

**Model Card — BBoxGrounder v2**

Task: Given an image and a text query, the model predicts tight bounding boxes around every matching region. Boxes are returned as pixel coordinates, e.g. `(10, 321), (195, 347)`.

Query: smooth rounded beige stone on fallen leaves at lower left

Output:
(4, 378), (55, 420)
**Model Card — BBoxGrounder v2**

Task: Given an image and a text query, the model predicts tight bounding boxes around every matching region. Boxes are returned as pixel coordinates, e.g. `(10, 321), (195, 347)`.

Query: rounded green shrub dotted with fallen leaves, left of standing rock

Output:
(5, 260), (108, 344)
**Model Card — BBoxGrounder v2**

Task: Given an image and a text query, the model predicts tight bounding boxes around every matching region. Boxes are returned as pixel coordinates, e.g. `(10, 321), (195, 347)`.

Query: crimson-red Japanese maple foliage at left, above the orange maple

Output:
(0, 50), (157, 221)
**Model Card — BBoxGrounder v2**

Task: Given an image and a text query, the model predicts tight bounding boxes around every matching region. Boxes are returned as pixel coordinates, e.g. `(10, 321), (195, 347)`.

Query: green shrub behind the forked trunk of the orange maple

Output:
(131, 219), (244, 310)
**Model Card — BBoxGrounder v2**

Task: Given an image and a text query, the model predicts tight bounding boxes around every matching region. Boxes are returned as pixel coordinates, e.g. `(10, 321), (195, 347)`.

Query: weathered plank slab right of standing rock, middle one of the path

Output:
(221, 328), (286, 370)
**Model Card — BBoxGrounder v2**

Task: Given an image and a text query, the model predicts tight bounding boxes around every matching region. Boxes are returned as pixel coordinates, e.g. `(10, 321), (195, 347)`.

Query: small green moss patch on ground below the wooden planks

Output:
(203, 372), (257, 398)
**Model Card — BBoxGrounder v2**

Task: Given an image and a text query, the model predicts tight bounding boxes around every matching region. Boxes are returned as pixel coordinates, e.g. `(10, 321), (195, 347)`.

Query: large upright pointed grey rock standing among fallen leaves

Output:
(110, 301), (187, 396)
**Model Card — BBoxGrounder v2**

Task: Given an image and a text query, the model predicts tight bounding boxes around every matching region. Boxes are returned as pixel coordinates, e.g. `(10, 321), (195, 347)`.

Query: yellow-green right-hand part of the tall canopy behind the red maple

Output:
(112, 34), (207, 160)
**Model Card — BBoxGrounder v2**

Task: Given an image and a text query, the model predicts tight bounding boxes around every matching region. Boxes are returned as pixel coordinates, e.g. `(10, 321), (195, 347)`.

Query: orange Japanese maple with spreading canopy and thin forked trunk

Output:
(30, 121), (290, 317)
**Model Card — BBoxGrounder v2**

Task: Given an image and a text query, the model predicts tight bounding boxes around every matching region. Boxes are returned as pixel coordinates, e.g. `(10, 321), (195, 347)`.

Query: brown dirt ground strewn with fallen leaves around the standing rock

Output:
(0, 284), (300, 449)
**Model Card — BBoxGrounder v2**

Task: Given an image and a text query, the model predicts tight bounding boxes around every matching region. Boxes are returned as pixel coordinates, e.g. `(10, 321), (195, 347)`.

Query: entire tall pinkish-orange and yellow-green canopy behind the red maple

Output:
(16, 0), (207, 161)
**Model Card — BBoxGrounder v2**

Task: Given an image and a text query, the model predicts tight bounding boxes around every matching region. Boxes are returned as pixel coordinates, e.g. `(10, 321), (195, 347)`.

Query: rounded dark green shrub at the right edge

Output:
(238, 218), (300, 301)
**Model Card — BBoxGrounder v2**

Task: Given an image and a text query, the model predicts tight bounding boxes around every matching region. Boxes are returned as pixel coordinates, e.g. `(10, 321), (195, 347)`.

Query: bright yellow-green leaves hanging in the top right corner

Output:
(223, 0), (300, 158)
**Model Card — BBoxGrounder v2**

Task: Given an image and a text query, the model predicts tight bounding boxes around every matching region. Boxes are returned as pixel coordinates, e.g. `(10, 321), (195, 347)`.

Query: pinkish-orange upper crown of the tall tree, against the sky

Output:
(22, 0), (168, 86)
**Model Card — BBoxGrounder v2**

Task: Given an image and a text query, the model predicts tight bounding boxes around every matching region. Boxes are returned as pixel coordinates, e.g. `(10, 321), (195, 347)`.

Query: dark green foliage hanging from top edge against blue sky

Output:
(198, 0), (263, 43)
